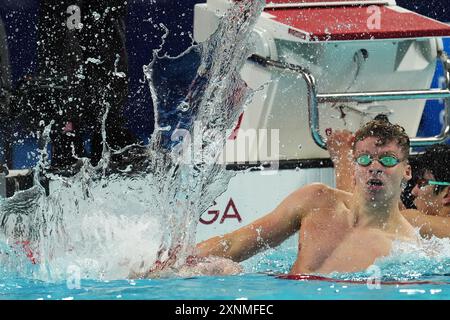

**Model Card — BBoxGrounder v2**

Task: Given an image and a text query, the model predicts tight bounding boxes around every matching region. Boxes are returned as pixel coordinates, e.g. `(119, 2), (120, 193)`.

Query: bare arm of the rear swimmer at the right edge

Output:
(402, 210), (450, 238)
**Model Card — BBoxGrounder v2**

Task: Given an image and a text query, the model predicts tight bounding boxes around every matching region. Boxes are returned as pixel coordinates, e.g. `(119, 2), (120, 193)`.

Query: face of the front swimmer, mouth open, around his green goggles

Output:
(354, 137), (411, 202)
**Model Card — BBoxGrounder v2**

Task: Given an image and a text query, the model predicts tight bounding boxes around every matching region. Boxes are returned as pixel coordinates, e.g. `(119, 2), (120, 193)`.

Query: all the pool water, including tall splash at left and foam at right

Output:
(0, 0), (450, 300)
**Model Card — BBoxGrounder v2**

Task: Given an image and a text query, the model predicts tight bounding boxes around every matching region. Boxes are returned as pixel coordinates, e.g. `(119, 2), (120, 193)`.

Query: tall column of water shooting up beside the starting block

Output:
(144, 1), (264, 276)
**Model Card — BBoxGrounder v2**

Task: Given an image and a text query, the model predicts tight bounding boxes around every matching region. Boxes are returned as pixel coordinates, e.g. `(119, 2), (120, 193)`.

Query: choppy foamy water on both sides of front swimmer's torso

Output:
(242, 229), (450, 285)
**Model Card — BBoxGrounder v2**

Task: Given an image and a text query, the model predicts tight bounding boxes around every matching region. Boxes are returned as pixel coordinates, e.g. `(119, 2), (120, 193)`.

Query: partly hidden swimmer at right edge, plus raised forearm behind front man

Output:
(327, 119), (450, 238)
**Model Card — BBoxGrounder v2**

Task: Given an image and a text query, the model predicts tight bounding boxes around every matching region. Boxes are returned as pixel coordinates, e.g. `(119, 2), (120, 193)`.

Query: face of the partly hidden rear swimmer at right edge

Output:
(411, 170), (448, 216)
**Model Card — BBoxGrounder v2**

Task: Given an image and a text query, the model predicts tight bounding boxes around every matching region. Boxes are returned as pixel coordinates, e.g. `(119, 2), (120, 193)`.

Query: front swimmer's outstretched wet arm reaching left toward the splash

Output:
(196, 184), (324, 262)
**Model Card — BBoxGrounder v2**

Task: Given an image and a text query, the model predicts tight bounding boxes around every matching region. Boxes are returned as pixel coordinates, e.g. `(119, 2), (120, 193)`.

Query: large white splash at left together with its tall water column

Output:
(0, 0), (264, 280)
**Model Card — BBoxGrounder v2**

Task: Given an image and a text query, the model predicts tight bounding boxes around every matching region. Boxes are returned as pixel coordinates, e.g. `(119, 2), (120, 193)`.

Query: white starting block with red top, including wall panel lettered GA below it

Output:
(194, 0), (450, 240)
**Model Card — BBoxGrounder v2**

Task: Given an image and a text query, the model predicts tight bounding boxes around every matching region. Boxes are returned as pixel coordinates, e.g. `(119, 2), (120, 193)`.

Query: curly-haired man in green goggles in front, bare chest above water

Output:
(196, 120), (419, 274)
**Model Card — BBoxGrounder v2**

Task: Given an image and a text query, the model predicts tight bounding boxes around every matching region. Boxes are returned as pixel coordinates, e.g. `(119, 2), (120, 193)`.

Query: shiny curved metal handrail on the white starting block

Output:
(249, 52), (450, 150)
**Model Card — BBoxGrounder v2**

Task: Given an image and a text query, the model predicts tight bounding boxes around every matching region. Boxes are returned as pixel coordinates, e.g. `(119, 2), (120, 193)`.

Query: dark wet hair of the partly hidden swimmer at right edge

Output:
(418, 143), (450, 194)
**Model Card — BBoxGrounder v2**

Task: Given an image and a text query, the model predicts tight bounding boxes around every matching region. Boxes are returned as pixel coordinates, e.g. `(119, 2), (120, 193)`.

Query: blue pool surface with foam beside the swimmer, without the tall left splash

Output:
(0, 237), (450, 300)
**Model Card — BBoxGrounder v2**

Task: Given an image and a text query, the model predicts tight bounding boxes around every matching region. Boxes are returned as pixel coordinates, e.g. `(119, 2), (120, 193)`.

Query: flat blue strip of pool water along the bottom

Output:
(0, 274), (450, 300)
